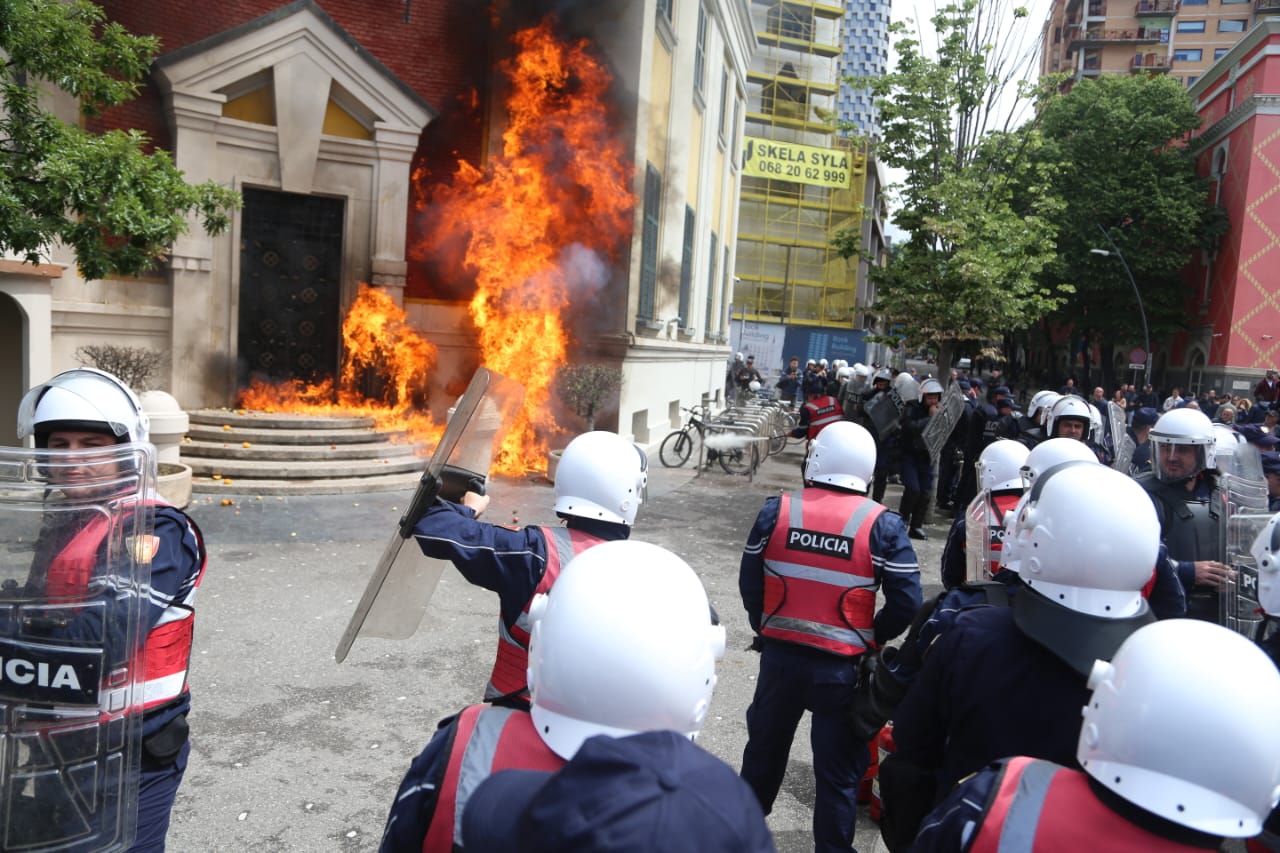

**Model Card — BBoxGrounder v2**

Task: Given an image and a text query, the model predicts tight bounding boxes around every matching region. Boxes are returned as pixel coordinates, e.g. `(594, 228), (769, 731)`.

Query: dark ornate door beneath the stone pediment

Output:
(236, 190), (343, 388)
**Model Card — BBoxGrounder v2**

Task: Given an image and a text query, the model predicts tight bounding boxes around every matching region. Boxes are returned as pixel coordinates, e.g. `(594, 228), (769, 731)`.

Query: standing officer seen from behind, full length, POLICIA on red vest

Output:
(739, 421), (920, 850)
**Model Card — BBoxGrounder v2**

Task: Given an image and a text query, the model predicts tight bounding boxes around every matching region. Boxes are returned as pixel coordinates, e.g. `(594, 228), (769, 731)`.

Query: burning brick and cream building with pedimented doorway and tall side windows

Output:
(0, 0), (754, 443)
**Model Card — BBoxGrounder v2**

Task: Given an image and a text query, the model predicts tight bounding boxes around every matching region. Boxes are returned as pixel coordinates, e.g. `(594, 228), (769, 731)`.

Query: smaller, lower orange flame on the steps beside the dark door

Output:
(238, 284), (444, 448)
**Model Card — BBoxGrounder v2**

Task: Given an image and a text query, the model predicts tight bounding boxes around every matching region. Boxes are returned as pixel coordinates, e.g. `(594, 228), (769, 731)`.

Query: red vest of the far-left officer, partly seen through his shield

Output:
(46, 501), (209, 711)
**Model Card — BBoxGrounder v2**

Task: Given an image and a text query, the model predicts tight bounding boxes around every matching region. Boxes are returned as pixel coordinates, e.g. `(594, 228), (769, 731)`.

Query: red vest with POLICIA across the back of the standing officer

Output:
(760, 488), (884, 657)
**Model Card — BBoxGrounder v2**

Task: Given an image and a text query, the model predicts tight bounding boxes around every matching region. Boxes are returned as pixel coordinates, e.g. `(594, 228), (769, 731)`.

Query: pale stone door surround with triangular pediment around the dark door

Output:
(155, 0), (435, 407)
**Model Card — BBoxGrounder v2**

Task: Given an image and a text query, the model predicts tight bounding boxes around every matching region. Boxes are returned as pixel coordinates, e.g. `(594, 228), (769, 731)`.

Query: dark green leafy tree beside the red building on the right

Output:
(1036, 74), (1226, 387)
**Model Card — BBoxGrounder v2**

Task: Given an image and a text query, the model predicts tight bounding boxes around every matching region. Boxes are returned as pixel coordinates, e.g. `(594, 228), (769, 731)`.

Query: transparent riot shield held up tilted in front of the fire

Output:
(334, 368), (525, 663)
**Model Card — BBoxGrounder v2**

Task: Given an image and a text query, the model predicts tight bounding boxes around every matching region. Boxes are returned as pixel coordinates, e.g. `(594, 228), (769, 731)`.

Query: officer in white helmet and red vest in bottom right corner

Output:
(911, 620), (1280, 853)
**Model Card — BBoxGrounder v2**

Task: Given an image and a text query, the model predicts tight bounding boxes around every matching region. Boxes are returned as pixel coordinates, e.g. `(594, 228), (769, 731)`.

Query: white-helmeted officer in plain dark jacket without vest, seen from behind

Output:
(879, 462), (1160, 849)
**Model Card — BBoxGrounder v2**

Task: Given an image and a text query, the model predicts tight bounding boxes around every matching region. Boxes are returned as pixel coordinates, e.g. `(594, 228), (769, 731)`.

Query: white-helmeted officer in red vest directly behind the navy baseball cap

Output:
(381, 542), (724, 853)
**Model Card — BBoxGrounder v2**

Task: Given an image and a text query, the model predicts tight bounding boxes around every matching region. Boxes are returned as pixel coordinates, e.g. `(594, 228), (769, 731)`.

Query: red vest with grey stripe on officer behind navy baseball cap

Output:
(422, 704), (564, 853)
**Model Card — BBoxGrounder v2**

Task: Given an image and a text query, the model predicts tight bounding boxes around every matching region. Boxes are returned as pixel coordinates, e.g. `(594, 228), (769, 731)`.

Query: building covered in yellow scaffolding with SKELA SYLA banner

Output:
(732, 0), (884, 371)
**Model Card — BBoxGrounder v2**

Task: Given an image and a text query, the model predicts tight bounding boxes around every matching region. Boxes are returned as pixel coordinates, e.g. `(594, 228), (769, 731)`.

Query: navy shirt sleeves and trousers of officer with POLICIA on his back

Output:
(739, 497), (922, 850)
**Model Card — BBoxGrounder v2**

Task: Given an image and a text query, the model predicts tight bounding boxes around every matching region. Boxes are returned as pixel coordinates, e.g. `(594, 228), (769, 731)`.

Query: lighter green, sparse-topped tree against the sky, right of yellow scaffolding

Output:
(837, 0), (1062, 364)
